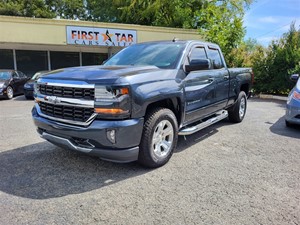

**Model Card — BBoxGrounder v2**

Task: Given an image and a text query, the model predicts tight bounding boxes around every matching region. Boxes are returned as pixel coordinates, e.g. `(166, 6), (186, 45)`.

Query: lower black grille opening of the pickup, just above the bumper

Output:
(39, 102), (94, 122)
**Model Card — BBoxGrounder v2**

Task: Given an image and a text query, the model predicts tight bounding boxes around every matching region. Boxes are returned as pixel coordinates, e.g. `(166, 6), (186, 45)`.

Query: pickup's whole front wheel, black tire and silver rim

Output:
(138, 108), (178, 168)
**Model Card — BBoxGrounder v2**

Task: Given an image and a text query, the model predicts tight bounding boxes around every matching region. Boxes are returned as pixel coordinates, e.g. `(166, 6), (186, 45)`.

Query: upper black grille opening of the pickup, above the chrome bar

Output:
(39, 84), (95, 100)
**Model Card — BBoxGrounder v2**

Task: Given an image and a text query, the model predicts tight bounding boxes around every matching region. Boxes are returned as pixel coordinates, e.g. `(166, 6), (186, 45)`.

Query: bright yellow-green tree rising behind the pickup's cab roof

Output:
(197, 0), (252, 58)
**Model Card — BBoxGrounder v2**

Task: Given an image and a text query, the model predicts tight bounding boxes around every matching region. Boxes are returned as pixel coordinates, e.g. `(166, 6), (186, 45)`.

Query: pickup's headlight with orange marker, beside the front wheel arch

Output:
(95, 86), (131, 118)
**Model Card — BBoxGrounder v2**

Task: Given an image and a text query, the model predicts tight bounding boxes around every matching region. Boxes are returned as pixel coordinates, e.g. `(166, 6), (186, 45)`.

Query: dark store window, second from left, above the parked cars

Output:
(16, 50), (48, 77)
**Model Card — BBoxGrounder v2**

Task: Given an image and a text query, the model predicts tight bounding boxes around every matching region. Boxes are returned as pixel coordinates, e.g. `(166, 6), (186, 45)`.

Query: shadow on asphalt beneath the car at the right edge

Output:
(270, 116), (300, 139)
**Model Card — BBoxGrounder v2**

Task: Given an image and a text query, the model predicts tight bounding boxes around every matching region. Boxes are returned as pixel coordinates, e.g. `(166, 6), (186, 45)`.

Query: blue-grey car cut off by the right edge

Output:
(285, 74), (300, 127)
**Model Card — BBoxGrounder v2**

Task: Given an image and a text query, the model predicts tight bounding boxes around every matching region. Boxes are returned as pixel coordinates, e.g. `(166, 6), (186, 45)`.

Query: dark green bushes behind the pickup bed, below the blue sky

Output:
(252, 23), (300, 94)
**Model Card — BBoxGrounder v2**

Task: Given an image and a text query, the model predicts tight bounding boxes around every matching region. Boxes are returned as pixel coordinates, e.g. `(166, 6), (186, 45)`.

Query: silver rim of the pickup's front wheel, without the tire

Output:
(151, 120), (174, 158)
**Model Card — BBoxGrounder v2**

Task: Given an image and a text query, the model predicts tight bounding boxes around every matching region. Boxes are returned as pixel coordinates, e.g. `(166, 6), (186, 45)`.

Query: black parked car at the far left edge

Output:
(0, 70), (28, 99)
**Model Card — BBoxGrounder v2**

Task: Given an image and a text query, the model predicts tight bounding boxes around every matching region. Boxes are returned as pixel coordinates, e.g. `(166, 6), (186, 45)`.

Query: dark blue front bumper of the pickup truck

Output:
(32, 107), (144, 162)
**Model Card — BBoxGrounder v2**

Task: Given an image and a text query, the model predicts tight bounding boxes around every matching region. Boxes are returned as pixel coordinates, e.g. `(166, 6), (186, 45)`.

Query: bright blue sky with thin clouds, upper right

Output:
(244, 0), (300, 46)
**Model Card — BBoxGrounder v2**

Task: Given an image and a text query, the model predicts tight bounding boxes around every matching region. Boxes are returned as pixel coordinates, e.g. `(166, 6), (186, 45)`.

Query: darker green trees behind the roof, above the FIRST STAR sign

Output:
(87, 0), (203, 28)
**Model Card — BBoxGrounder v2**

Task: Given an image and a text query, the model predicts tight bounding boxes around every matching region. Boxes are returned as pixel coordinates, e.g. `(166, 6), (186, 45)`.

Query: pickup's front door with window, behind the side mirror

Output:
(184, 45), (217, 123)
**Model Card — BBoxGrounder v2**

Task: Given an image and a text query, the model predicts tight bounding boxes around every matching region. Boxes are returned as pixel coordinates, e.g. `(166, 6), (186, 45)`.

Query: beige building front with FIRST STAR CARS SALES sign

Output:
(0, 16), (201, 76)
